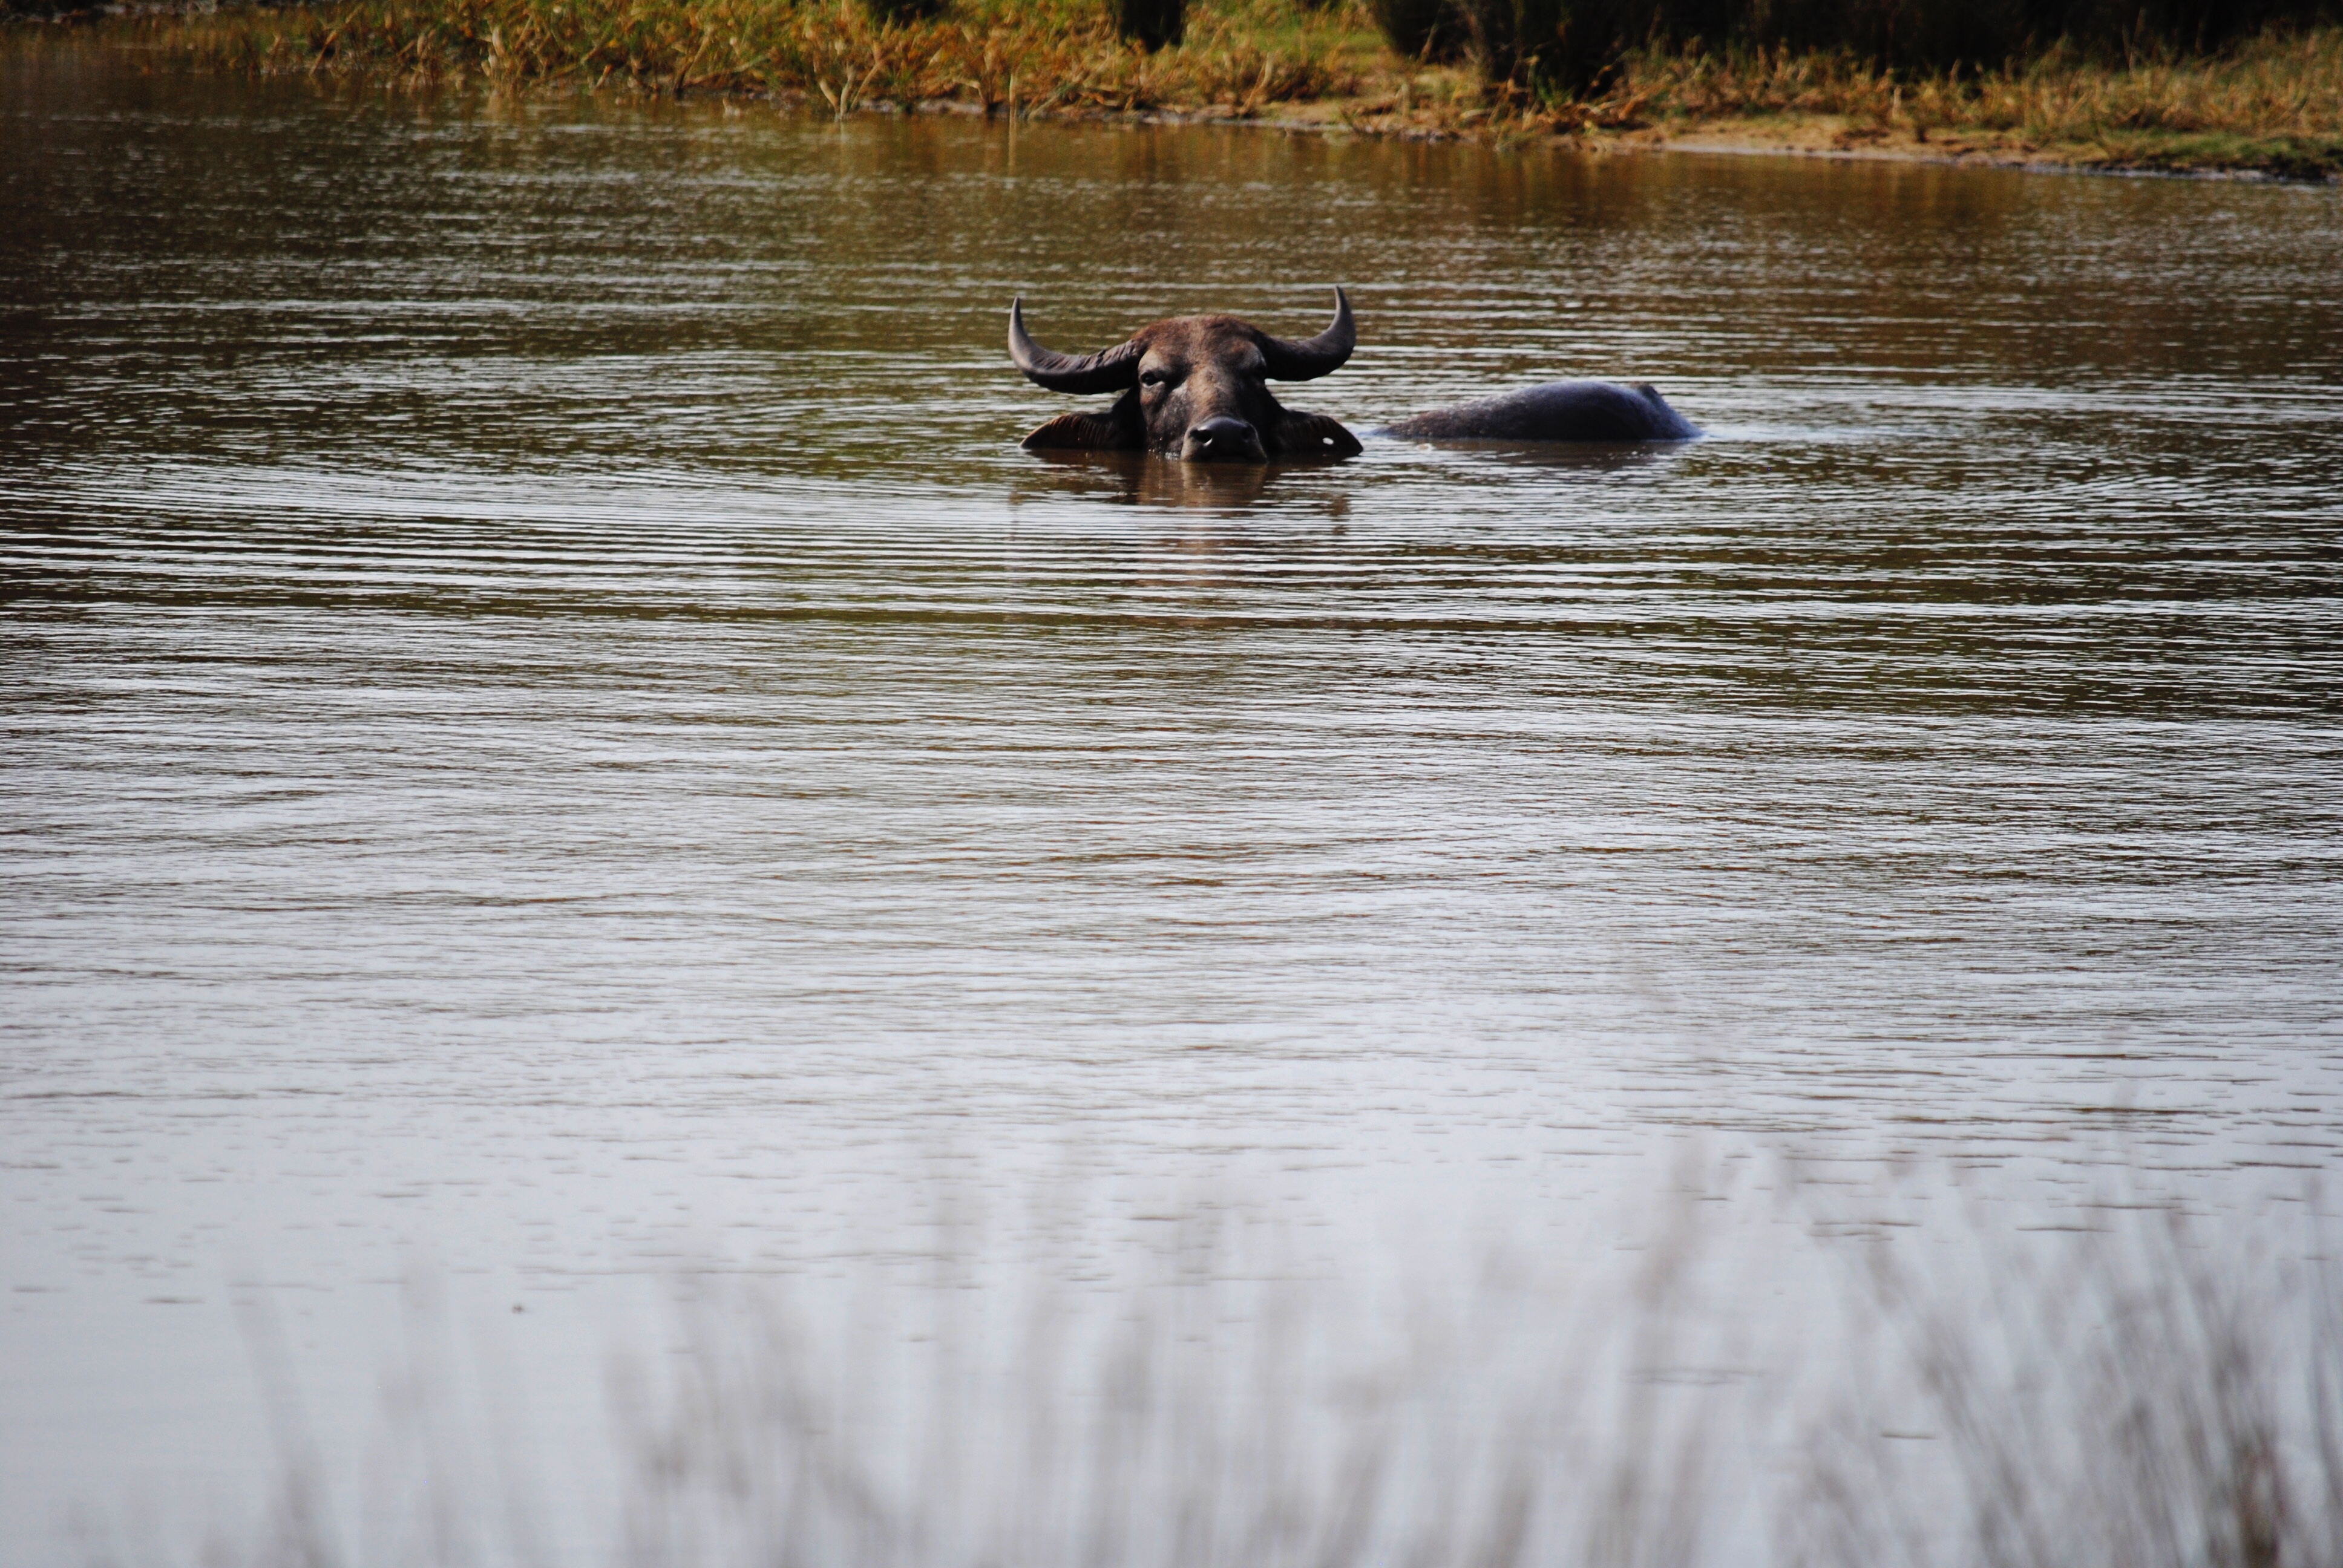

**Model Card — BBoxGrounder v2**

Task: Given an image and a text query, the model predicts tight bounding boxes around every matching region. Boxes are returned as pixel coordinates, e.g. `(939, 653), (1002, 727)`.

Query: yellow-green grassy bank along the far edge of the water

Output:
(28, 0), (2343, 178)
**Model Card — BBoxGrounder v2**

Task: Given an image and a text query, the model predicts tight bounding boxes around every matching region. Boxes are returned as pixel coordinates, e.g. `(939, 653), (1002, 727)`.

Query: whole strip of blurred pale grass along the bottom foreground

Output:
(94, 1165), (2343, 1568)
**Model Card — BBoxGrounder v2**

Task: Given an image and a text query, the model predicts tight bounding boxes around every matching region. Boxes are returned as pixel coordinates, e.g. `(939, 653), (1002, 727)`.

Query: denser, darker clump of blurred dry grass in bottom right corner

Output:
(1792, 1186), (2343, 1568)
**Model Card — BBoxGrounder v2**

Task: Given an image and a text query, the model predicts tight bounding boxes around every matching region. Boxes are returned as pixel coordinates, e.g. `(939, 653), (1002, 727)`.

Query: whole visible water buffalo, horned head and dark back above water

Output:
(1010, 289), (1701, 462)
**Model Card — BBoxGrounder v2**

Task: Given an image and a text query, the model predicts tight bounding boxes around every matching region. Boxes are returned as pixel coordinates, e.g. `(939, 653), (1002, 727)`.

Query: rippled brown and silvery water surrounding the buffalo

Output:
(0, 49), (2343, 1563)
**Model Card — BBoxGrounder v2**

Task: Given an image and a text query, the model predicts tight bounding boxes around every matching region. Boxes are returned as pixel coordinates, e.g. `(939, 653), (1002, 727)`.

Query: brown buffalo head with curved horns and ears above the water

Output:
(1010, 289), (1359, 462)
